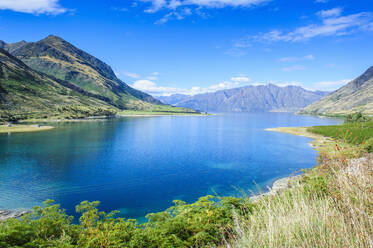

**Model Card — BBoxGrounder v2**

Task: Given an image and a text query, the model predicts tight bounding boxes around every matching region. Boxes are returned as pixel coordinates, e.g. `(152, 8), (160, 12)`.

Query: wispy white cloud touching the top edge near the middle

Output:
(137, 0), (270, 24)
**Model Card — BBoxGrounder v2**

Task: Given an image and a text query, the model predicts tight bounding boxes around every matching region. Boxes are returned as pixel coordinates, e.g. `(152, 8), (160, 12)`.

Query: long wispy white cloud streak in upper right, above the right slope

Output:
(245, 8), (373, 43)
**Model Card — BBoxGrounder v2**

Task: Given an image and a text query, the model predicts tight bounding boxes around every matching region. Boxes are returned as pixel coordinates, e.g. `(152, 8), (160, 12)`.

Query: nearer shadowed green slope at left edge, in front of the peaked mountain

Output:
(0, 48), (118, 120)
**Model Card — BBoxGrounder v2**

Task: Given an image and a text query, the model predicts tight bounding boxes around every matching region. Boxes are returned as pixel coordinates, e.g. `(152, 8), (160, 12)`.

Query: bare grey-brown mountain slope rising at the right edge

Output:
(300, 66), (373, 115)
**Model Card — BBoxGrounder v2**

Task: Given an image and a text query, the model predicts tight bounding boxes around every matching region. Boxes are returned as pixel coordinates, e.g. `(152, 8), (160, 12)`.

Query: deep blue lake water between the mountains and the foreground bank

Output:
(0, 113), (340, 218)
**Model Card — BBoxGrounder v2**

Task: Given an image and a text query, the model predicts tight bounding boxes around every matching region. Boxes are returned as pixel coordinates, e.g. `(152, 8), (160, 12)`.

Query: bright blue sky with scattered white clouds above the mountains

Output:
(0, 0), (373, 95)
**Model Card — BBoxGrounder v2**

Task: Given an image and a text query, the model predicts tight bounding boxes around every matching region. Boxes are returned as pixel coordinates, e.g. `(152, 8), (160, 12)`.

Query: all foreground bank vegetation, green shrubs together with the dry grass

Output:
(0, 114), (373, 248)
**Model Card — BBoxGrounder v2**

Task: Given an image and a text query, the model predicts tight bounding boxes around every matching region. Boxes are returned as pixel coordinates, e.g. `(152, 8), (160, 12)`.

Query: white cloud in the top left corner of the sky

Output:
(0, 0), (67, 15)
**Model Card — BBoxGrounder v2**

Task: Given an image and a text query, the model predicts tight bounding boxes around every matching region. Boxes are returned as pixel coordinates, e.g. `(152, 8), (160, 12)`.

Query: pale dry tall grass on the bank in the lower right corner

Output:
(227, 157), (373, 248)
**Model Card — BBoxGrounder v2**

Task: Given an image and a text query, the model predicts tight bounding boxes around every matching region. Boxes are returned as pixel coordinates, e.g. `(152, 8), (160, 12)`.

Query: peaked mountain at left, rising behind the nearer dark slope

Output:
(0, 35), (162, 110)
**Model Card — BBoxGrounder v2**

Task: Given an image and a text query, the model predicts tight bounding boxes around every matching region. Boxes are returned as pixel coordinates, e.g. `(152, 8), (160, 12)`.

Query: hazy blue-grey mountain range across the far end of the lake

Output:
(158, 84), (328, 112)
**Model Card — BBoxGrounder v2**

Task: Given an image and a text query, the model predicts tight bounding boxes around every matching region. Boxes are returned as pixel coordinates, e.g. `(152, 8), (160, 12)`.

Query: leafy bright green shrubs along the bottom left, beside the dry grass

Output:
(0, 196), (252, 248)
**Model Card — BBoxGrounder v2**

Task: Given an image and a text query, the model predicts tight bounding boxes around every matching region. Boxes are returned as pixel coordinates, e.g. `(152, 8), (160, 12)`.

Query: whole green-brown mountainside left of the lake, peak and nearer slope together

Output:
(0, 35), (192, 119)
